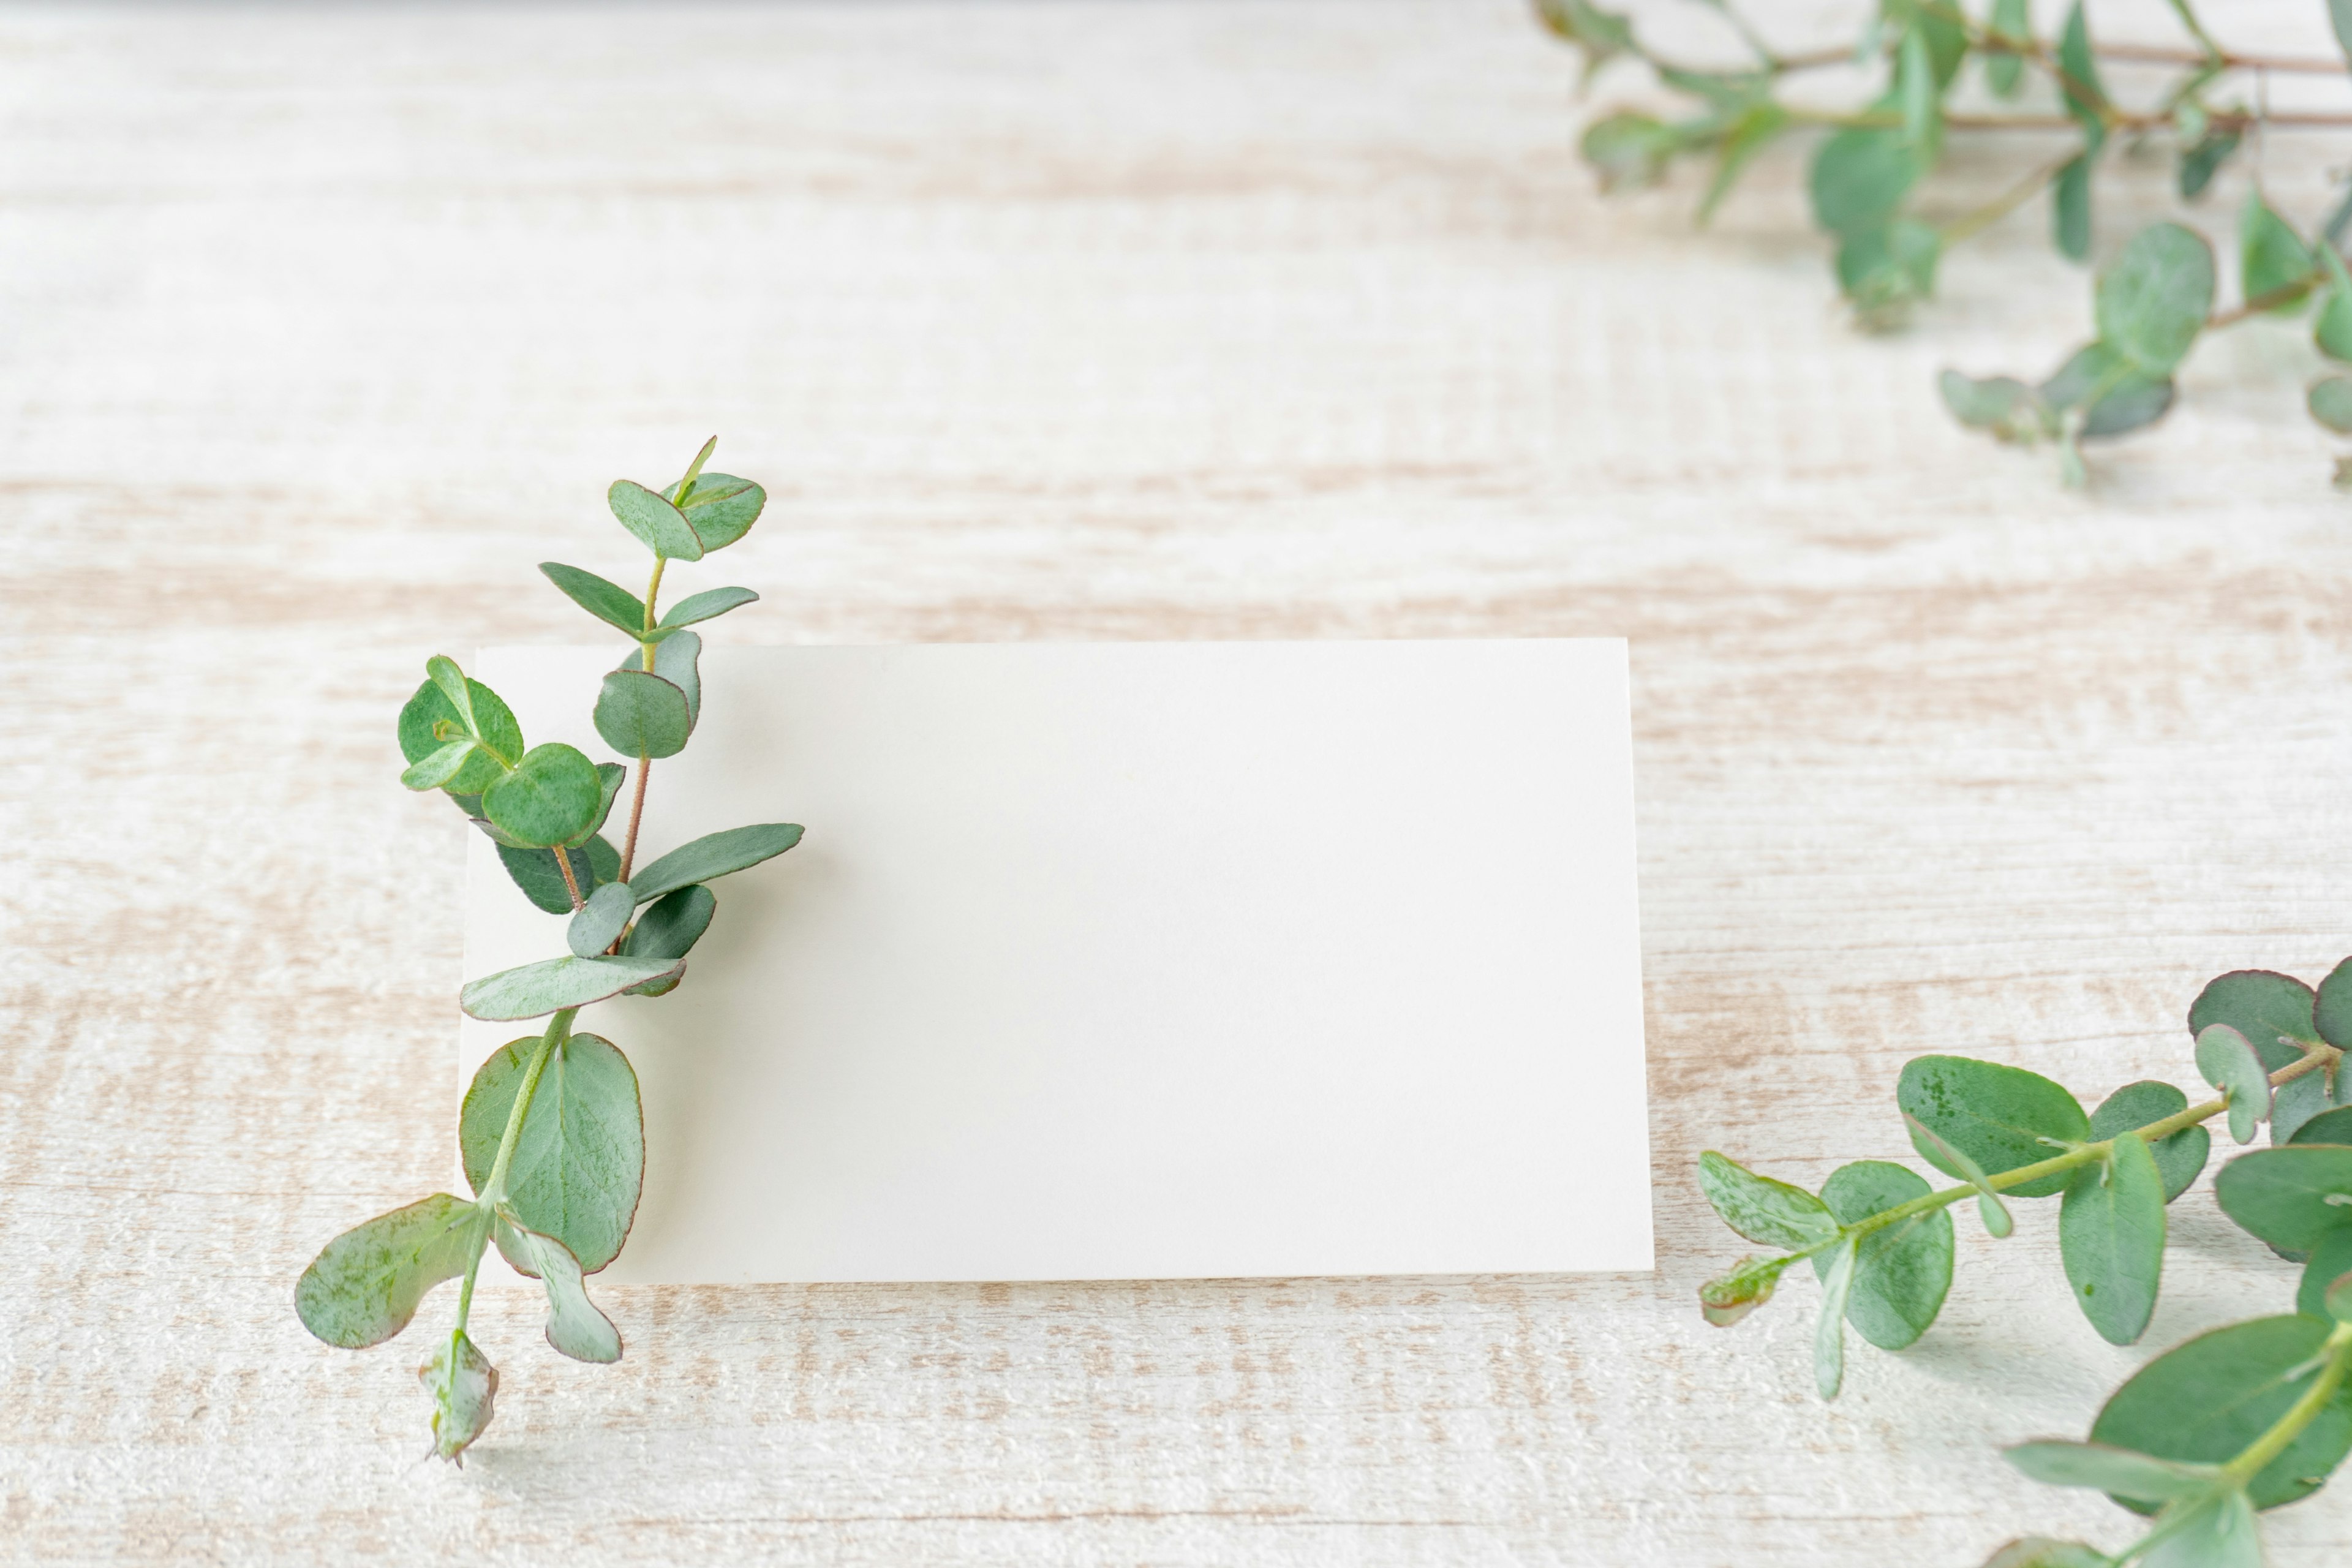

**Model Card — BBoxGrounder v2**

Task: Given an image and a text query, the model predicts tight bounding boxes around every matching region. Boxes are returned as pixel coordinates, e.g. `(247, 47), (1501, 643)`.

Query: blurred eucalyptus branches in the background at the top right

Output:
(1534, 0), (2352, 486)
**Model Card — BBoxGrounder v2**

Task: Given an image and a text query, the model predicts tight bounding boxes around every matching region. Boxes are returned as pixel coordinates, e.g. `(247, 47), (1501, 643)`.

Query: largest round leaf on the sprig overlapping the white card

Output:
(456, 1035), (644, 1274)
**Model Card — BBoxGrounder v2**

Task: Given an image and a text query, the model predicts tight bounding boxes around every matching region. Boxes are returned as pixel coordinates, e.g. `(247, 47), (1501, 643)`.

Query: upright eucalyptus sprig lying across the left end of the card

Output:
(294, 437), (802, 1460)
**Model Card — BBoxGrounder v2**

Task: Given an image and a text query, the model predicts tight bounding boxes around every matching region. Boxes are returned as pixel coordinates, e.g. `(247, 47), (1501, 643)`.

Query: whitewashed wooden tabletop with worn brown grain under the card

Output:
(13, 0), (2352, 1568)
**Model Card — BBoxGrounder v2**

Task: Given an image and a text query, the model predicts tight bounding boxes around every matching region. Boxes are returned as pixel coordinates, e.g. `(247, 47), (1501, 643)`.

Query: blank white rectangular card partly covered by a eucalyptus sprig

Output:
(461, 639), (1651, 1284)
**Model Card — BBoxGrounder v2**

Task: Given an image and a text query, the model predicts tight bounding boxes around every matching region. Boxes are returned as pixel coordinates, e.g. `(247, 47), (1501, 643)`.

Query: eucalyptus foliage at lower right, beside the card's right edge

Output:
(1698, 959), (2352, 1568)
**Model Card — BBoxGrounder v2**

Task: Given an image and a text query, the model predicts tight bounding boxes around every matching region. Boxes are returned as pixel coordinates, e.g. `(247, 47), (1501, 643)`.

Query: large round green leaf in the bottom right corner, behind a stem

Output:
(2091, 1316), (2352, 1514)
